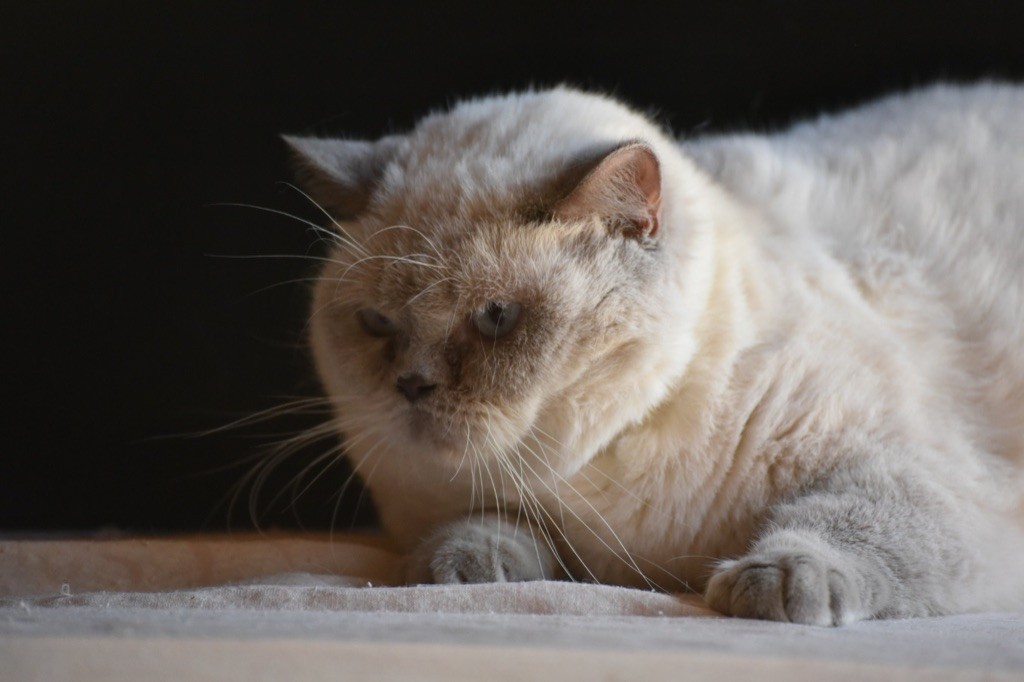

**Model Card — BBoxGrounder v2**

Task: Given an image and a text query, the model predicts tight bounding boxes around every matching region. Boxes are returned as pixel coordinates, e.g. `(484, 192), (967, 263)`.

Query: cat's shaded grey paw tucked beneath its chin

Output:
(406, 515), (559, 583)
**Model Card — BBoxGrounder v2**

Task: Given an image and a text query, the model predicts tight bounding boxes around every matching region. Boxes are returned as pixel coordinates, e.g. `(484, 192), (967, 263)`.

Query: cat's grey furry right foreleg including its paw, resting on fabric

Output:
(706, 464), (980, 626)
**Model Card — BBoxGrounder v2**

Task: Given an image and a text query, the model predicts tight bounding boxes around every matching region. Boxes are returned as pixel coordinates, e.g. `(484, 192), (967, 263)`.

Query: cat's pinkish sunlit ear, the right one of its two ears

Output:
(554, 142), (662, 240)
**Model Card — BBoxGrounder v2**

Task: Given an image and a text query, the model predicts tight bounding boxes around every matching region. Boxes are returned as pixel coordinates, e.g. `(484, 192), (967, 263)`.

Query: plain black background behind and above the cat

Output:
(0, 0), (1024, 532)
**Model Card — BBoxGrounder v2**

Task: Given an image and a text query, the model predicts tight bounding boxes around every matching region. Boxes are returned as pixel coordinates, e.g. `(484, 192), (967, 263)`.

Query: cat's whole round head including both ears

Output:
(286, 89), (708, 483)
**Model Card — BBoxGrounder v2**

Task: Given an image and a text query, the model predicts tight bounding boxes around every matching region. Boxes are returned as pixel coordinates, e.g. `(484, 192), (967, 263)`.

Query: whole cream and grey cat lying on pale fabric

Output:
(286, 83), (1024, 626)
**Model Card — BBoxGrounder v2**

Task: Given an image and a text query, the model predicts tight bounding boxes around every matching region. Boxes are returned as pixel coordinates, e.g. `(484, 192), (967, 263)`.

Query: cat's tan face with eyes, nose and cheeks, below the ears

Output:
(311, 209), (644, 471)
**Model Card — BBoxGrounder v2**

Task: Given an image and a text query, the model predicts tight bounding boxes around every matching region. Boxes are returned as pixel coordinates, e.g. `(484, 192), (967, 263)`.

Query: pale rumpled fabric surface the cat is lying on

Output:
(0, 536), (1024, 681)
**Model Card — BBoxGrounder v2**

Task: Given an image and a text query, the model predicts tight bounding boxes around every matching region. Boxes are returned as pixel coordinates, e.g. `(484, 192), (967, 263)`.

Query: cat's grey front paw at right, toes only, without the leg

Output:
(705, 551), (863, 626)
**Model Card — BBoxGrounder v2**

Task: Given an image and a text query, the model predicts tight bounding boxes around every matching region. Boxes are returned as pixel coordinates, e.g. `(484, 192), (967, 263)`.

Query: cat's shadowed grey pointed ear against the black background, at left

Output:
(282, 135), (398, 220)
